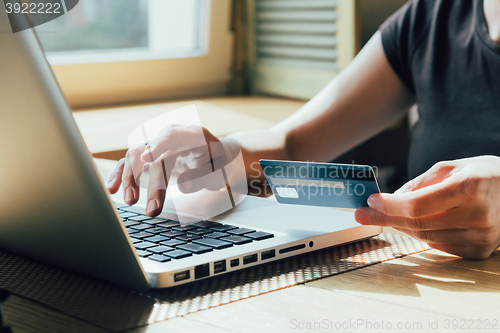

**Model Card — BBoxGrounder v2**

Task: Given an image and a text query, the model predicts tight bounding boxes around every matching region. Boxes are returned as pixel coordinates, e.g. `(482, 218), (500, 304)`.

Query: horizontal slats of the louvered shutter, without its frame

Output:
(256, 0), (337, 69)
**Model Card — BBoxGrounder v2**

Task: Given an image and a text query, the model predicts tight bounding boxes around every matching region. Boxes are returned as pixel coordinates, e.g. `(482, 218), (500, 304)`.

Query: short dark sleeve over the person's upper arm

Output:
(379, 0), (433, 92)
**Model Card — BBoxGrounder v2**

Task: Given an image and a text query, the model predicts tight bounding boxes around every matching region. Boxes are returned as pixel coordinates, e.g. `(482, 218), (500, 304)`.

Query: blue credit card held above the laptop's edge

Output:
(259, 160), (380, 209)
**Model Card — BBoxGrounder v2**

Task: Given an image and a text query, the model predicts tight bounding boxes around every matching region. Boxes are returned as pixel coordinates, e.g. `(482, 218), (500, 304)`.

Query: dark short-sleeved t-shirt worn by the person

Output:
(380, 0), (500, 178)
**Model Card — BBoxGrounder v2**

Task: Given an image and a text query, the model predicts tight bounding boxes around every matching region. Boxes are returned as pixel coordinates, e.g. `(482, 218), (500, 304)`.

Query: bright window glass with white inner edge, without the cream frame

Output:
(35, 0), (208, 64)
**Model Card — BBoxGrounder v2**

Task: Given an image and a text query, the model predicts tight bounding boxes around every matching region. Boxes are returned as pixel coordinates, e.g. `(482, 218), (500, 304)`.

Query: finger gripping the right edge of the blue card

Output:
(368, 177), (463, 218)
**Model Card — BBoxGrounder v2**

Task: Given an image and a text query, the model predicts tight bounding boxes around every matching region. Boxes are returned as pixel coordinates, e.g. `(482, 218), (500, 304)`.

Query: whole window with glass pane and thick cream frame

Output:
(36, 0), (233, 108)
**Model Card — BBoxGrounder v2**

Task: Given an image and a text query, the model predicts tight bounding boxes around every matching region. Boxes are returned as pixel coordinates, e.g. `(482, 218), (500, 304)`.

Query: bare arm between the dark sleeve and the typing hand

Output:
(230, 32), (414, 183)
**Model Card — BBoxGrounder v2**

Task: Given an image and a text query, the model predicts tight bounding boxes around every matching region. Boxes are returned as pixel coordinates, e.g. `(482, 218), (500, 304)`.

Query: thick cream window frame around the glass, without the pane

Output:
(49, 0), (233, 108)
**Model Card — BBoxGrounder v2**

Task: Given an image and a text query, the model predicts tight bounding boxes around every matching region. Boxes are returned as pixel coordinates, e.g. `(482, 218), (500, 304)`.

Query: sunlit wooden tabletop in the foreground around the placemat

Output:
(4, 98), (500, 333)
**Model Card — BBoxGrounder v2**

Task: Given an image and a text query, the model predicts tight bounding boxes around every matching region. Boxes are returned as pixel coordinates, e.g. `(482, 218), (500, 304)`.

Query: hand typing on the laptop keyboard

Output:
(107, 125), (242, 216)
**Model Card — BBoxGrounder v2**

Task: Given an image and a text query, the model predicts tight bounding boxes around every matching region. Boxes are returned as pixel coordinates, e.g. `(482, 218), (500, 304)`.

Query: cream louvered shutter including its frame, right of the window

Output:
(253, 0), (356, 99)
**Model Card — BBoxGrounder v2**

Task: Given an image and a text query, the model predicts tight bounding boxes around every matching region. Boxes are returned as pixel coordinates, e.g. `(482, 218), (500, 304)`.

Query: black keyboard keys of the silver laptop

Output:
(115, 203), (274, 262)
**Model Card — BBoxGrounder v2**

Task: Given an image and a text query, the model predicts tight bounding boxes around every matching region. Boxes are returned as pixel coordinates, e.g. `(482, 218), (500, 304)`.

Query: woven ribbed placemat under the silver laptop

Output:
(0, 233), (429, 331)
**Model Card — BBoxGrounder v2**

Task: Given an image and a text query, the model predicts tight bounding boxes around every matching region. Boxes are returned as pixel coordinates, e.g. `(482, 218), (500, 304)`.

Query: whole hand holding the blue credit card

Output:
(355, 156), (500, 259)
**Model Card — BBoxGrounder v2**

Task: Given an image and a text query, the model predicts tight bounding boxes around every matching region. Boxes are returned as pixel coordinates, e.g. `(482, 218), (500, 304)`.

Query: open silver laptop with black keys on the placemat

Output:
(0, 2), (382, 291)
